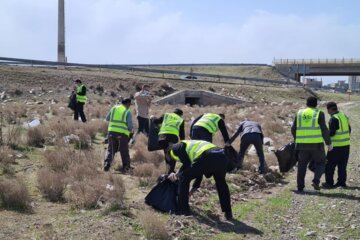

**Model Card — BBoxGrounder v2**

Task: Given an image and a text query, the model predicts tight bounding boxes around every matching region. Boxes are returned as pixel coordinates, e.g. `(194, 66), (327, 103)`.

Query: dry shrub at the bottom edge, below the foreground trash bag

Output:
(140, 210), (170, 240)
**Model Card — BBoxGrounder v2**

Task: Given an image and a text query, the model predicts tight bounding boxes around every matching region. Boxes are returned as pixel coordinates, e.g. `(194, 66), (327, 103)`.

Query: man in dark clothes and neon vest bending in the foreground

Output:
(166, 140), (233, 220)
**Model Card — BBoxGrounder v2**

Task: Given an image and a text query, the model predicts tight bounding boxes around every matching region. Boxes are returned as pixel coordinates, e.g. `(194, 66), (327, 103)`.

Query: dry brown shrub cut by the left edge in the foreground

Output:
(0, 177), (31, 211)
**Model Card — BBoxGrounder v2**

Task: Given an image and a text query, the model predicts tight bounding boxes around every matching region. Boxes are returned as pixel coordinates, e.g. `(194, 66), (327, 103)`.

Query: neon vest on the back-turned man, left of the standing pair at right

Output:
(295, 108), (324, 144)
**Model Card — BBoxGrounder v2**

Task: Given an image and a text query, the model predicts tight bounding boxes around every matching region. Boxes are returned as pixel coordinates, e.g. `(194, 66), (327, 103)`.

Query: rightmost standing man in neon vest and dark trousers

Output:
(322, 102), (351, 188)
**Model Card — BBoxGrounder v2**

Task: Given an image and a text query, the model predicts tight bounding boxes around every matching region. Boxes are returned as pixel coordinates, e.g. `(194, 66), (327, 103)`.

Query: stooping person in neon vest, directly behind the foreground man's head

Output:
(151, 108), (185, 173)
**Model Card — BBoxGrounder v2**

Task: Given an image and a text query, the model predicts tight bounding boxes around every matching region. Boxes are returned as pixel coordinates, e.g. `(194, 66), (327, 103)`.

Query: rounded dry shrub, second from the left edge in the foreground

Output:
(37, 168), (66, 202)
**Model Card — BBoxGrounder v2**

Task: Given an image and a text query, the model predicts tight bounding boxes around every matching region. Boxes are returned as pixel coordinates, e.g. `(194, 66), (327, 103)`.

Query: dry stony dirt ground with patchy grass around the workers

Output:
(0, 66), (360, 240)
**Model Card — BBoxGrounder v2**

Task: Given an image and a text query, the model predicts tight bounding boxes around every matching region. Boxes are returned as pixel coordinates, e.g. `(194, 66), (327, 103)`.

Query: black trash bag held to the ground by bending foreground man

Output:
(145, 179), (178, 213)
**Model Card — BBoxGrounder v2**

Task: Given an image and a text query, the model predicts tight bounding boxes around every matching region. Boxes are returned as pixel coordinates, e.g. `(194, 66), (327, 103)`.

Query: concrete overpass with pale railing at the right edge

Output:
(273, 58), (360, 82)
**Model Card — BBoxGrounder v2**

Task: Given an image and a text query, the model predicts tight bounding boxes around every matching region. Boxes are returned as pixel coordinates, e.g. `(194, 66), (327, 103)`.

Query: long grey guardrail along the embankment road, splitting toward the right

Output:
(0, 57), (299, 85)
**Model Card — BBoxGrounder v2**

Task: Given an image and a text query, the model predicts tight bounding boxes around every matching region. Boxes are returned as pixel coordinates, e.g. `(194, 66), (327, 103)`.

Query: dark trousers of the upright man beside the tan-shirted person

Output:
(105, 133), (130, 169)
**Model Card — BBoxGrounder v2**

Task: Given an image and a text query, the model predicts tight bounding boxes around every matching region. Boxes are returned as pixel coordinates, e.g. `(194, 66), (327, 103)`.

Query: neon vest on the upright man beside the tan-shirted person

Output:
(108, 105), (130, 136)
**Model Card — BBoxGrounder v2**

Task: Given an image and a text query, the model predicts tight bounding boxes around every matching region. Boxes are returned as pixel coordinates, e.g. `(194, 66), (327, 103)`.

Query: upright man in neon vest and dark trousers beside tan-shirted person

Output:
(104, 98), (133, 173)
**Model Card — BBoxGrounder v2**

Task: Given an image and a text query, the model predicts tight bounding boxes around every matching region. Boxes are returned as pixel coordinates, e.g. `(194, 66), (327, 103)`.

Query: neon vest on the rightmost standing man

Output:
(331, 112), (350, 147)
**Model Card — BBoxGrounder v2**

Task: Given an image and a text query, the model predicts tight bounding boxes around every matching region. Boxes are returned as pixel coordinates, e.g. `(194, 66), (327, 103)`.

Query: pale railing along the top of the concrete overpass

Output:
(273, 58), (360, 65)
